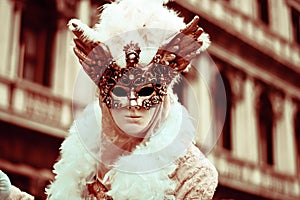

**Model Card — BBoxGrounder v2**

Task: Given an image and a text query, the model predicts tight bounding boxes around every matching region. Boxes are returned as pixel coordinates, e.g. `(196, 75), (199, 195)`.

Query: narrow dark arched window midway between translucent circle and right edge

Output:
(258, 91), (274, 165)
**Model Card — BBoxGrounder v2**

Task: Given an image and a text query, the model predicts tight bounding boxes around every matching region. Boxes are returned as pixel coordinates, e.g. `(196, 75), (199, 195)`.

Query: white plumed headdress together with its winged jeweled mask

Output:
(69, 0), (210, 109)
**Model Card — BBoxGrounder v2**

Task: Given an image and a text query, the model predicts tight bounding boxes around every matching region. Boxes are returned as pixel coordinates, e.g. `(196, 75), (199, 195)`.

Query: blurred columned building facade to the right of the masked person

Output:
(174, 0), (300, 199)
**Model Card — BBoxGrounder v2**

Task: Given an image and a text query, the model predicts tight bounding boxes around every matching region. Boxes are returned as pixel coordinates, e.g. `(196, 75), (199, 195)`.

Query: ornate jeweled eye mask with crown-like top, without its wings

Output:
(99, 43), (178, 110)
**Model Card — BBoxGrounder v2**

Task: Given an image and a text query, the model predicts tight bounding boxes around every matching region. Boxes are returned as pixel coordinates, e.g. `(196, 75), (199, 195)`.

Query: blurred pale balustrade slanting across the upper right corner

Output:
(176, 0), (300, 72)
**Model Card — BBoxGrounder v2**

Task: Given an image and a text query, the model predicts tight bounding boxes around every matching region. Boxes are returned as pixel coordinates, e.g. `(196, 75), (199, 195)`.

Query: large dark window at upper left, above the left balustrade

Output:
(19, 0), (56, 86)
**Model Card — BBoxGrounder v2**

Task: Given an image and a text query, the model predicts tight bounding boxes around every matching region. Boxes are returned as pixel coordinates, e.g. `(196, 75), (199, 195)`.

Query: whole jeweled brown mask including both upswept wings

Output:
(69, 16), (209, 109)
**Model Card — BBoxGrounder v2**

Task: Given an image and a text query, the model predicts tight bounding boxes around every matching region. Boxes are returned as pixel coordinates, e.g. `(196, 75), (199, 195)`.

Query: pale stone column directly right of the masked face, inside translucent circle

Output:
(184, 56), (216, 150)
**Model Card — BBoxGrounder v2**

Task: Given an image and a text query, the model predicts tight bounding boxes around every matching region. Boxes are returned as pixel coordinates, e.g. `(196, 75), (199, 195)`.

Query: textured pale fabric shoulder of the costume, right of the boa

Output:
(172, 145), (218, 200)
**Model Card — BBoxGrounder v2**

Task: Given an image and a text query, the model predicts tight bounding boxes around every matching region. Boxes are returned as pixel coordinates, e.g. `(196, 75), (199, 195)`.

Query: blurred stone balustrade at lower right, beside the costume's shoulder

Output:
(210, 149), (300, 200)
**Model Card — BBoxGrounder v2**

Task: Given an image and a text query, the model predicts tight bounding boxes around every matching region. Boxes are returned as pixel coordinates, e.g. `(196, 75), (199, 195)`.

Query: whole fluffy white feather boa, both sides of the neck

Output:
(46, 102), (194, 200)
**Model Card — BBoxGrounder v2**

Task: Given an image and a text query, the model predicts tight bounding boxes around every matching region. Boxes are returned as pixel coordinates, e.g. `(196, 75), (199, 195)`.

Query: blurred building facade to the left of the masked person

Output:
(0, 0), (86, 199)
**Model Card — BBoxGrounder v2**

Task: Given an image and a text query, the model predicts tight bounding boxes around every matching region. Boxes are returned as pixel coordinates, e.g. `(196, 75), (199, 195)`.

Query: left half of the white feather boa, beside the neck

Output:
(46, 103), (101, 200)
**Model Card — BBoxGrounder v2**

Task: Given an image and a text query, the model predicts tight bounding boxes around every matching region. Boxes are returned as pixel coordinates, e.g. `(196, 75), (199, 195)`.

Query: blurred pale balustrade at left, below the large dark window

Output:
(0, 77), (73, 137)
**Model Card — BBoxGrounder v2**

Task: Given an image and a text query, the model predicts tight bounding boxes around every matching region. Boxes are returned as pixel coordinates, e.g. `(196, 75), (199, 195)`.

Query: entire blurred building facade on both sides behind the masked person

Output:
(0, 0), (300, 200)
